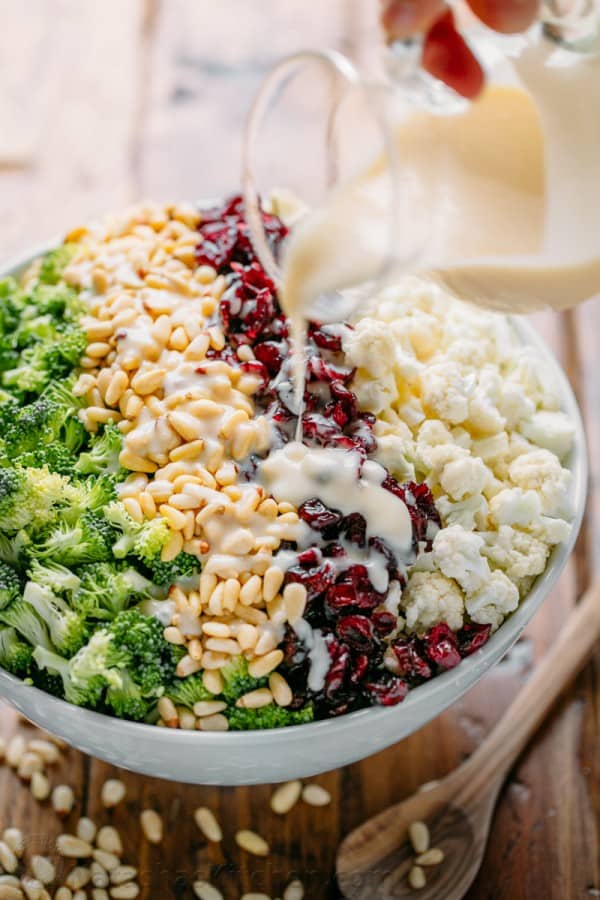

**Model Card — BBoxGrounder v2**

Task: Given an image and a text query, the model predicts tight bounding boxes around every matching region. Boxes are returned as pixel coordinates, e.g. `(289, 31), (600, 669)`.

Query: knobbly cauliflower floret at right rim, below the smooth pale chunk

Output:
(508, 450), (573, 519)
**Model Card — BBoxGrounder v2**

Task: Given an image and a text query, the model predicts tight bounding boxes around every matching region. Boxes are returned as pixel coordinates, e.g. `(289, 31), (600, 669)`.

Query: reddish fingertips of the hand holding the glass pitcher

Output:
(381, 0), (540, 99)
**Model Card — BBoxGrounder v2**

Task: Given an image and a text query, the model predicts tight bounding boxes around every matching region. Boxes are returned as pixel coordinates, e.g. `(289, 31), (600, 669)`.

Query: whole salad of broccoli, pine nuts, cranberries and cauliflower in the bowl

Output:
(0, 197), (577, 744)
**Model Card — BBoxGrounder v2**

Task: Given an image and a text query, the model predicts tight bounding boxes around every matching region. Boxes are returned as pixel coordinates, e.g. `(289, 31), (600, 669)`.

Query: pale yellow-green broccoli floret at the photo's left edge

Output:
(0, 467), (68, 532)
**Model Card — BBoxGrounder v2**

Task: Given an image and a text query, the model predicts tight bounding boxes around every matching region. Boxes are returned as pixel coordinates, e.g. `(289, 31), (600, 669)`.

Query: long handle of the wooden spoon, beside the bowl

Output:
(459, 579), (600, 788)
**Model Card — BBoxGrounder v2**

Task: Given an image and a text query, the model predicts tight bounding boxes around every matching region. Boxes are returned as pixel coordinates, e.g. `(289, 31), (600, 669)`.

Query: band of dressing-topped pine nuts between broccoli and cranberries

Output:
(65, 206), (306, 692)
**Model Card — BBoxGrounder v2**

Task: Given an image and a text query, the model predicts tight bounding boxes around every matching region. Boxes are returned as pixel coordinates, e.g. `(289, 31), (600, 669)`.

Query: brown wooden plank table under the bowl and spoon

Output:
(0, 0), (600, 900)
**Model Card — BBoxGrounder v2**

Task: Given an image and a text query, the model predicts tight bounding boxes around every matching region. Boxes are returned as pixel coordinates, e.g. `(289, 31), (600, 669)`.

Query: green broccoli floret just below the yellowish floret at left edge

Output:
(29, 512), (114, 567)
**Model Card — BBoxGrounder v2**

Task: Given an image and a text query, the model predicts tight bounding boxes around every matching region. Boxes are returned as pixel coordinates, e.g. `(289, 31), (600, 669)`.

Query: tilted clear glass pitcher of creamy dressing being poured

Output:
(243, 0), (600, 321)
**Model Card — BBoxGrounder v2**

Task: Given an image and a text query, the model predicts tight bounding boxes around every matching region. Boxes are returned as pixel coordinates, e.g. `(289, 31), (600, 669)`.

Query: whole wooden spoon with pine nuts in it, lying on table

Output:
(337, 580), (600, 900)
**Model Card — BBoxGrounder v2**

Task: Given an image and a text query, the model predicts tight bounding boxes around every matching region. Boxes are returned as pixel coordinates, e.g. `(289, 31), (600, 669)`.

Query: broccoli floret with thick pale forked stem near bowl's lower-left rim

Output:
(33, 648), (106, 709)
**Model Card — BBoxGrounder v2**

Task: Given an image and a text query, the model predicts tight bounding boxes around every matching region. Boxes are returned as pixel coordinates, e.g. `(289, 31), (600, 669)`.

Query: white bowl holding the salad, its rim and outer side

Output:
(0, 243), (587, 785)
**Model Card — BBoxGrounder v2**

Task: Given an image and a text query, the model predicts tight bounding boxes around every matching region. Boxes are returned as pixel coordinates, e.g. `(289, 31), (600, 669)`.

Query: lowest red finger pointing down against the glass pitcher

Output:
(422, 10), (485, 100)
